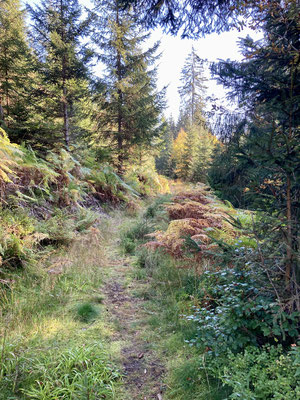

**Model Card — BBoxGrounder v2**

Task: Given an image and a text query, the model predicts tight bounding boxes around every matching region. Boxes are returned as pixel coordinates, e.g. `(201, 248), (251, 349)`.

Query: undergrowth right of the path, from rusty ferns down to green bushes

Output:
(121, 185), (300, 400)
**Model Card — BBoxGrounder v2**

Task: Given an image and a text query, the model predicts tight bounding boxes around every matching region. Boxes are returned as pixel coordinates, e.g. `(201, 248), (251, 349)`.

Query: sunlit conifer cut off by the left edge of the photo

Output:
(0, 0), (31, 139)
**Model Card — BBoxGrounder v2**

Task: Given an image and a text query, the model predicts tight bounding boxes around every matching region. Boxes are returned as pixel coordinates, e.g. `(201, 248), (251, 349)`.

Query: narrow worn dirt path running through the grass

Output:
(102, 214), (164, 400)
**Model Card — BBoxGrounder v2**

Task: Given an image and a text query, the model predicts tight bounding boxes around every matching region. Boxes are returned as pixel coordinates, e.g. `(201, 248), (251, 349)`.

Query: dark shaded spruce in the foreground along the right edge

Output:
(213, 0), (300, 294)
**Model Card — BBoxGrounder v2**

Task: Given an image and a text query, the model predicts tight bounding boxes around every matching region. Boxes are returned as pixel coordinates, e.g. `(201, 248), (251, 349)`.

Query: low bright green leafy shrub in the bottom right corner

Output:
(219, 346), (300, 400)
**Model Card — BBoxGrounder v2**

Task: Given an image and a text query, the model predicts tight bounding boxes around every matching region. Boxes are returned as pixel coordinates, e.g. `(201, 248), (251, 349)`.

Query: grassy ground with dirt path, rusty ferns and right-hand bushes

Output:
(0, 180), (299, 400)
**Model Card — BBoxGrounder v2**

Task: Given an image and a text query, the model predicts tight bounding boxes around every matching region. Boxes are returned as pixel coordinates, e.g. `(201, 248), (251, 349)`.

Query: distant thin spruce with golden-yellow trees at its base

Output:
(156, 47), (218, 182)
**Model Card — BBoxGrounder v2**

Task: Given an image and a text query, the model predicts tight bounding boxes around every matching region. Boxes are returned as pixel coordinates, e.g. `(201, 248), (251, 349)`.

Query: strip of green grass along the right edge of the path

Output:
(123, 198), (229, 400)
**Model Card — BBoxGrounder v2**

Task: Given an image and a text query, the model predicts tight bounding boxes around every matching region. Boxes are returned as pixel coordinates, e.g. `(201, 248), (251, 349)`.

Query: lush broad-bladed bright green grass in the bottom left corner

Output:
(0, 338), (120, 400)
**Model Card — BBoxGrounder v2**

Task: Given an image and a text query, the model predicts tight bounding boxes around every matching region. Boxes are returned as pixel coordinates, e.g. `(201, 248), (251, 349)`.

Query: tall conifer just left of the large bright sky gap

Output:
(95, 0), (164, 174)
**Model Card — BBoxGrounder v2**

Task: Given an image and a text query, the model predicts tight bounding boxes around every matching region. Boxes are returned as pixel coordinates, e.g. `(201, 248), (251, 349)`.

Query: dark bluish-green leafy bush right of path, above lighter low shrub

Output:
(186, 268), (299, 355)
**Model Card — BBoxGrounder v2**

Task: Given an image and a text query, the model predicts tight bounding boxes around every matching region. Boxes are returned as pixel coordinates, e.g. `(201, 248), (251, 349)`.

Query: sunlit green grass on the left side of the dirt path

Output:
(0, 220), (121, 400)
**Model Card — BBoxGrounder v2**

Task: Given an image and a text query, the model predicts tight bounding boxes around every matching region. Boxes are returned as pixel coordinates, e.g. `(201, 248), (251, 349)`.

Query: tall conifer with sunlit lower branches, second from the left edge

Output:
(28, 0), (92, 149)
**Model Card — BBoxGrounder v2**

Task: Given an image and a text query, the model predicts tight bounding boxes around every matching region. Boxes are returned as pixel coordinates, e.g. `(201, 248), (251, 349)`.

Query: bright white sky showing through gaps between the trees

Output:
(23, 0), (261, 120)
